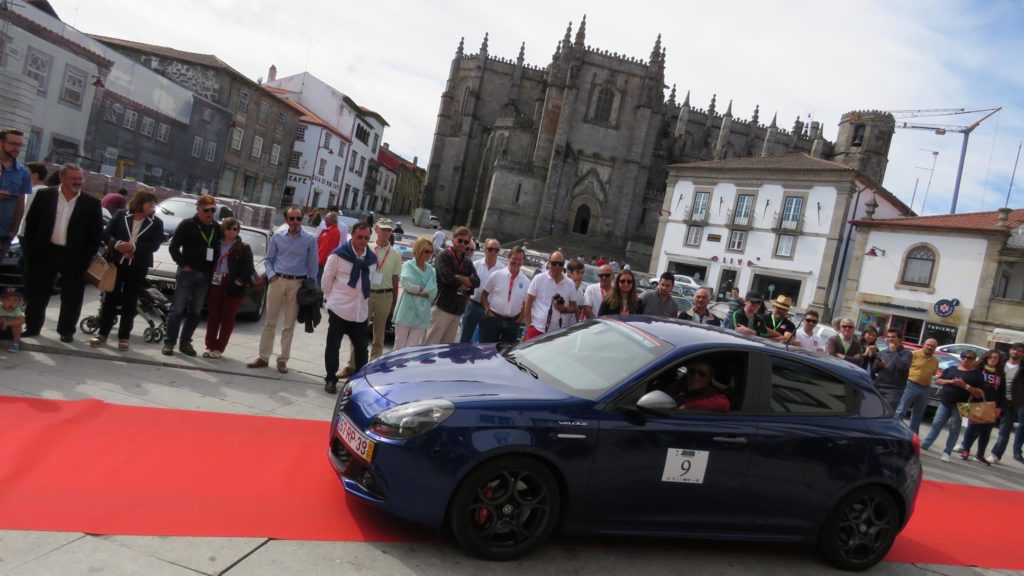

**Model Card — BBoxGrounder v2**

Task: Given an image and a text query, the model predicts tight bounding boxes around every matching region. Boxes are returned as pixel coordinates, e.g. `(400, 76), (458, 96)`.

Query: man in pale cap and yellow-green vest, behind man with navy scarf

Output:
(337, 217), (401, 380)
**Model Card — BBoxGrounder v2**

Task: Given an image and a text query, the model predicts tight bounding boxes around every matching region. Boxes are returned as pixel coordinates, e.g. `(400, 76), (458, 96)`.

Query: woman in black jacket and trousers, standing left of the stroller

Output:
(89, 190), (164, 351)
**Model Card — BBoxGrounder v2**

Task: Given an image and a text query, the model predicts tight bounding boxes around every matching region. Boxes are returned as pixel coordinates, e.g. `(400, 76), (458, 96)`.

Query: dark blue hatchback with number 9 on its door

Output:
(330, 316), (922, 570)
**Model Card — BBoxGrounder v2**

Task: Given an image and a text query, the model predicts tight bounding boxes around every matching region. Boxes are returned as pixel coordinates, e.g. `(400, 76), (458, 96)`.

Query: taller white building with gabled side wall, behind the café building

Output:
(266, 72), (388, 210)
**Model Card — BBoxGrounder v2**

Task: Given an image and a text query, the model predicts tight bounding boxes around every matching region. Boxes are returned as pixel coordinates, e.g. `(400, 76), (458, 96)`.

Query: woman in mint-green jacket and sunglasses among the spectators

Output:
(394, 237), (437, 349)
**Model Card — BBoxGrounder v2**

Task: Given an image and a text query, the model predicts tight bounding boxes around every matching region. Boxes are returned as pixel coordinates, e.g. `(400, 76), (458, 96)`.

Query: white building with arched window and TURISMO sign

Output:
(843, 209), (1024, 346)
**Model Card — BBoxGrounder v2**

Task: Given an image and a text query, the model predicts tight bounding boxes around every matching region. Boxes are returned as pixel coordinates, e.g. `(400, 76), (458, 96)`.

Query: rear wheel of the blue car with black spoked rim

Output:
(818, 486), (902, 571)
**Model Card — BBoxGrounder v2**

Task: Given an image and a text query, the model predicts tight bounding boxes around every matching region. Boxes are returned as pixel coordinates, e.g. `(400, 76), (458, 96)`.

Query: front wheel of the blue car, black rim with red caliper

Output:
(449, 456), (561, 561)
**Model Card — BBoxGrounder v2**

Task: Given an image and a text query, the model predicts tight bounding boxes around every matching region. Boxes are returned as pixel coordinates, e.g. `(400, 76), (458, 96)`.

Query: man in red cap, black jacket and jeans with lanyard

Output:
(160, 194), (221, 356)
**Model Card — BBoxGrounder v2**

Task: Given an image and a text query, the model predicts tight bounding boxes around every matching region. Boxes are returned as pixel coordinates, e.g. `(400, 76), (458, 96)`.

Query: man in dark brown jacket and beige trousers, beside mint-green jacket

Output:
(425, 227), (480, 344)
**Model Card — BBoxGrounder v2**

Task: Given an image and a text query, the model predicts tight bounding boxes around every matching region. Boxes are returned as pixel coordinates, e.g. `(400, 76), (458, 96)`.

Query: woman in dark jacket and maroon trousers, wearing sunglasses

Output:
(203, 217), (256, 359)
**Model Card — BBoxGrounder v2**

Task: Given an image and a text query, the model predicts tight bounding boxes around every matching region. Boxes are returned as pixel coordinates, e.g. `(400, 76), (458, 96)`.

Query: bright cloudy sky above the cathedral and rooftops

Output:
(51, 0), (1024, 214)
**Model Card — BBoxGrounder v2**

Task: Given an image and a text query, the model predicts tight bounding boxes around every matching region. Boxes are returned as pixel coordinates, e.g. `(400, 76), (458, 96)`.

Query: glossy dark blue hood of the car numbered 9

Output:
(364, 344), (573, 404)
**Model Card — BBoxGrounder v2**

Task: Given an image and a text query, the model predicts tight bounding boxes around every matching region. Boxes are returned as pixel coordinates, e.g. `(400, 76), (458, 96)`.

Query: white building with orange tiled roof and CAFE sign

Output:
(266, 87), (351, 208)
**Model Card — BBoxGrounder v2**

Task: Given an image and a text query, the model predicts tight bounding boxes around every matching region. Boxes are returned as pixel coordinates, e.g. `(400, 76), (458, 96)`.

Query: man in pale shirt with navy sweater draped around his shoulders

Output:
(321, 221), (377, 394)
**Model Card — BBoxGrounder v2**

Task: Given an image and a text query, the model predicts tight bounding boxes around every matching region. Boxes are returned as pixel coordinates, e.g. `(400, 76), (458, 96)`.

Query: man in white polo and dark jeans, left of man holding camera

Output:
(480, 246), (529, 343)
